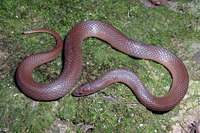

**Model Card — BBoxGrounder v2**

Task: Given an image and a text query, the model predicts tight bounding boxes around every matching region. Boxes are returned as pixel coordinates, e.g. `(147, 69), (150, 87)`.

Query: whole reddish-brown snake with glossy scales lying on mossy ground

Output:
(16, 21), (189, 111)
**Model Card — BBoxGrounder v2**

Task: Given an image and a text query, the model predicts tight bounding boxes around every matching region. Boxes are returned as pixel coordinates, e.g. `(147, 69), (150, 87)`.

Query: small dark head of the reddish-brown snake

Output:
(72, 82), (91, 97)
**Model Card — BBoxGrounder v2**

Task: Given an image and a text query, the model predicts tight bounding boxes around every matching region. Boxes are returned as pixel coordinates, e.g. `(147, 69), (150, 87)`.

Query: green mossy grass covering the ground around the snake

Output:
(0, 0), (200, 133)
